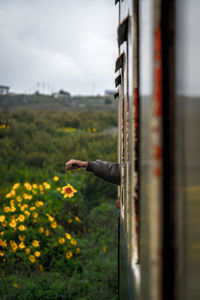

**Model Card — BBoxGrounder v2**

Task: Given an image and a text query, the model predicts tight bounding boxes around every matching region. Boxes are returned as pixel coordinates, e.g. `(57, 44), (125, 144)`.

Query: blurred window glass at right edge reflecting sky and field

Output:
(176, 0), (200, 300)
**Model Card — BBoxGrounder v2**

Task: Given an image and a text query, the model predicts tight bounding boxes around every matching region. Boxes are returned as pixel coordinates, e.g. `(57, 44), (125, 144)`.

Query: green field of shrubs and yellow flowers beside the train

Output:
(0, 110), (117, 300)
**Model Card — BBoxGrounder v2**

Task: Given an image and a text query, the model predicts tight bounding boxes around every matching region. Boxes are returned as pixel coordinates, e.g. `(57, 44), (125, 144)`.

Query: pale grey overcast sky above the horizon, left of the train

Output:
(0, 0), (117, 95)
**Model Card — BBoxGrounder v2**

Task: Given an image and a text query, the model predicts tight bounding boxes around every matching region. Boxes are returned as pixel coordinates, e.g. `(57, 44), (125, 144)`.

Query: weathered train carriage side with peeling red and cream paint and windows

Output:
(115, 0), (200, 300)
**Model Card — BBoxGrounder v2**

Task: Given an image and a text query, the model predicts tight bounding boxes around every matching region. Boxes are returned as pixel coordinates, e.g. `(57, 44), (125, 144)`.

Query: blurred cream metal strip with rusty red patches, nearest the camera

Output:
(149, 0), (163, 300)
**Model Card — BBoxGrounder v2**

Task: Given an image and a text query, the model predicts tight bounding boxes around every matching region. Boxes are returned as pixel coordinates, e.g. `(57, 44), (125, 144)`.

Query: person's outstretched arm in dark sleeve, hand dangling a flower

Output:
(66, 159), (121, 185)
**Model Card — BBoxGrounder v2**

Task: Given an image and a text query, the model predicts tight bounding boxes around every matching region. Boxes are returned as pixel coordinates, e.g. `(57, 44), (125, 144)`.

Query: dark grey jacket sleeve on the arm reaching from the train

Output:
(86, 159), (121, 185)
